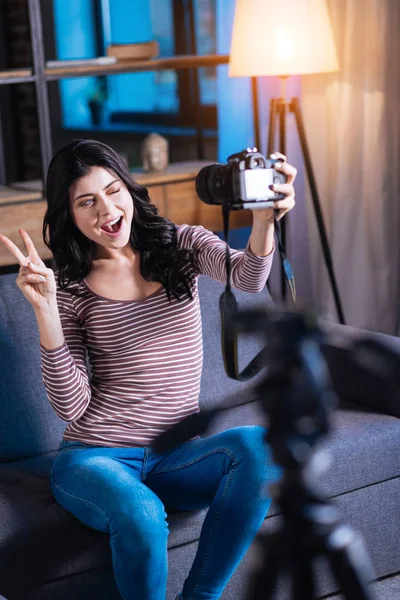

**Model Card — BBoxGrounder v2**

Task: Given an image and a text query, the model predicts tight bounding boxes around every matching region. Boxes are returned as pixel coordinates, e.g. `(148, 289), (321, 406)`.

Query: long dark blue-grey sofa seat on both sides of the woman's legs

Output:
(0, 403), (400, 595)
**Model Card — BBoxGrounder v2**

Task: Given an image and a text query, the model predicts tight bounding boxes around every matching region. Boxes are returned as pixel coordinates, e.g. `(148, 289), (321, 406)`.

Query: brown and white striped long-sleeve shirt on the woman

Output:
(40, 225), (272, 447)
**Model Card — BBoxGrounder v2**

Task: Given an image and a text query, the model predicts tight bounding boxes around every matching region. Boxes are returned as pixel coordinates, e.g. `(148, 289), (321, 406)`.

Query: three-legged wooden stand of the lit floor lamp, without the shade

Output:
(252, 77), (345, 325)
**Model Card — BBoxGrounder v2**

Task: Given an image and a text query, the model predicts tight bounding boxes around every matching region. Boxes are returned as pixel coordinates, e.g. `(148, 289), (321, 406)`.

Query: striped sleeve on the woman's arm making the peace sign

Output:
(40, 291), (91, 421)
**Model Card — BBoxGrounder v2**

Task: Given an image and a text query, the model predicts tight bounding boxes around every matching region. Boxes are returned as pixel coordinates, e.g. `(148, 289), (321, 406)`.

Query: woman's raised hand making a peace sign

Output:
(0, 229), (57, 311)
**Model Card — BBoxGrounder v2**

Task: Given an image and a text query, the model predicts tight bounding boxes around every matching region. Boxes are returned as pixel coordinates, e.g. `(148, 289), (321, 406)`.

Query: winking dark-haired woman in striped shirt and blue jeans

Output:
(0, 140), (296, 600)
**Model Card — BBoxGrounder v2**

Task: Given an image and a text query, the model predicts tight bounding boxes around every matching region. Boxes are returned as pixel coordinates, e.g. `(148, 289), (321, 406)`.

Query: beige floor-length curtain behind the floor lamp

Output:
(302, 0), (400, 335)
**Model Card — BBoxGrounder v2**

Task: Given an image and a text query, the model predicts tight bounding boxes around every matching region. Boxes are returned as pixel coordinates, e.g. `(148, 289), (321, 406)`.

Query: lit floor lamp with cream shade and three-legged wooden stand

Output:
(229, 0), (345, 324)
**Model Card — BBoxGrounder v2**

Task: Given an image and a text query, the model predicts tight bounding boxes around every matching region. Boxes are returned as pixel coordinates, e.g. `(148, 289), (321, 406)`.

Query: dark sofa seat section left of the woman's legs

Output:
(0, 466), (110, 597)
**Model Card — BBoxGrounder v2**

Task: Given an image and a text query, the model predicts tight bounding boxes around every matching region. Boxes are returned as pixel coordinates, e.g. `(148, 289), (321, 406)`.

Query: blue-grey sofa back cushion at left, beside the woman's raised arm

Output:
(0, 274), (66, 462)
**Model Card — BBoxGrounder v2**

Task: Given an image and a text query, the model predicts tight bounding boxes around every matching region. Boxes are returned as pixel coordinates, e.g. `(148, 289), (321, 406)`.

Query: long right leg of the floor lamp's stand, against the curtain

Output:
(290, 98), (345, 325)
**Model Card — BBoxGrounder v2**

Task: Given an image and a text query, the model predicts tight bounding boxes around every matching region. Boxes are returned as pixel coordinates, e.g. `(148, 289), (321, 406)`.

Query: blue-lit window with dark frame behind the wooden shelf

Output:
(101, 0), (216, 129)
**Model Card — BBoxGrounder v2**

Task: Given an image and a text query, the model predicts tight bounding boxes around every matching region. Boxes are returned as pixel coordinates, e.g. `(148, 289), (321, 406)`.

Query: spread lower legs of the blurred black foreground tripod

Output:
(248, 466), (373, 600)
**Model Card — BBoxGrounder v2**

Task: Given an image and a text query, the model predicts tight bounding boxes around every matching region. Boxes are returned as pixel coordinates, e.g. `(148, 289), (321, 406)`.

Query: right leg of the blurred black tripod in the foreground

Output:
(327, 526), (374, 600)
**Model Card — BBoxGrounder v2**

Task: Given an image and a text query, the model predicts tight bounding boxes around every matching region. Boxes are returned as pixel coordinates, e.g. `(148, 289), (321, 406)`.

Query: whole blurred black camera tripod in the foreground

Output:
(241, 313), (373, 600)
